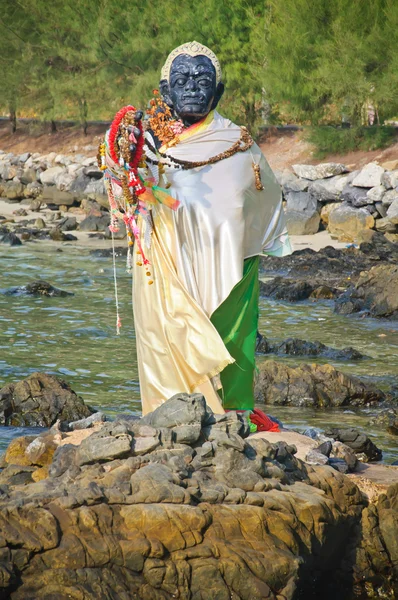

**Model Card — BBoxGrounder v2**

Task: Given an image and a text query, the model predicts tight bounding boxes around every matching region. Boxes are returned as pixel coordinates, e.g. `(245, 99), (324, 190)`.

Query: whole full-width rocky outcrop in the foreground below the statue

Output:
(0, 381), (398, 600)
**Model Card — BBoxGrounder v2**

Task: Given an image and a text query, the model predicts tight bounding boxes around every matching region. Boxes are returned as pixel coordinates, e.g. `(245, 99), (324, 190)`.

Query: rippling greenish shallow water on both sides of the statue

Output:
(0, 242), (398, 462)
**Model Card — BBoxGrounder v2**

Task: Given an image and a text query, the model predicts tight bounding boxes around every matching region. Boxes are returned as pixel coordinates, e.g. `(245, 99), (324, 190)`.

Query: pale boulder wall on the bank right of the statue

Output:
(277, 160), (398, 242)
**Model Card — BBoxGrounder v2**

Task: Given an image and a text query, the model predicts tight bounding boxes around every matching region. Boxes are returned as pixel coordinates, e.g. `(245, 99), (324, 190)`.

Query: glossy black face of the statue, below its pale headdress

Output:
(160, 54), (224, 125)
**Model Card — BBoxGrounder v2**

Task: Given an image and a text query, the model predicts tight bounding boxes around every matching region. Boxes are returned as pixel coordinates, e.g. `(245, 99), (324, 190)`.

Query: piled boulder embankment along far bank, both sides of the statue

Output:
(0, 151), (398, 245)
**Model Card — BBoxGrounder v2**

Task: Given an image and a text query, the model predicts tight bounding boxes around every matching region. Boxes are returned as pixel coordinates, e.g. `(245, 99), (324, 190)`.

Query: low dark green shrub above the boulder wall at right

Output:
(304, 125), (397, 158)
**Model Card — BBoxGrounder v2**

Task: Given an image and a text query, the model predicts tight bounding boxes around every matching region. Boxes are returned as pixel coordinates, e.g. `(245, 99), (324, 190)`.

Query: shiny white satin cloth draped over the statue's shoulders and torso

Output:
(157, 111), (286, 316)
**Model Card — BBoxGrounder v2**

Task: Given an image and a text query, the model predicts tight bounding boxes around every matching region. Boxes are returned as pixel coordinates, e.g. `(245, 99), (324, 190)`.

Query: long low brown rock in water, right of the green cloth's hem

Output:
(255, 360), (385, 408)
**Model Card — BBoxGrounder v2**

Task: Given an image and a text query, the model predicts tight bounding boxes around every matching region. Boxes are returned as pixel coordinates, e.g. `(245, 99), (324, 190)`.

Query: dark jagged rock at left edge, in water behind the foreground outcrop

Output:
(0, 373), (92, 427)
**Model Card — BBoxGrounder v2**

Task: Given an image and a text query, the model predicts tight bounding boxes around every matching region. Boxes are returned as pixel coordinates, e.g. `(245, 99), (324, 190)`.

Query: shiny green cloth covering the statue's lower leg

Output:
(211, 256), (259, 410)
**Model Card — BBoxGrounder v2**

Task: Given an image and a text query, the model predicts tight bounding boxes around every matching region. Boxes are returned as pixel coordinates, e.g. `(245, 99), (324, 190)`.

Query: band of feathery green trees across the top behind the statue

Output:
(0, 0), (398, 135)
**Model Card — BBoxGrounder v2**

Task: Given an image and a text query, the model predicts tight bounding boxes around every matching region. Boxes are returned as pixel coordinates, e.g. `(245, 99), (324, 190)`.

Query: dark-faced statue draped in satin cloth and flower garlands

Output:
(99, 42), (291, 414)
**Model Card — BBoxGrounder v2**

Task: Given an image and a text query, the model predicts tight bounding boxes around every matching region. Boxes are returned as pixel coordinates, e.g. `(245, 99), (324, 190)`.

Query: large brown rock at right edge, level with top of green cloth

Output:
(335, 265), (398, 318)
